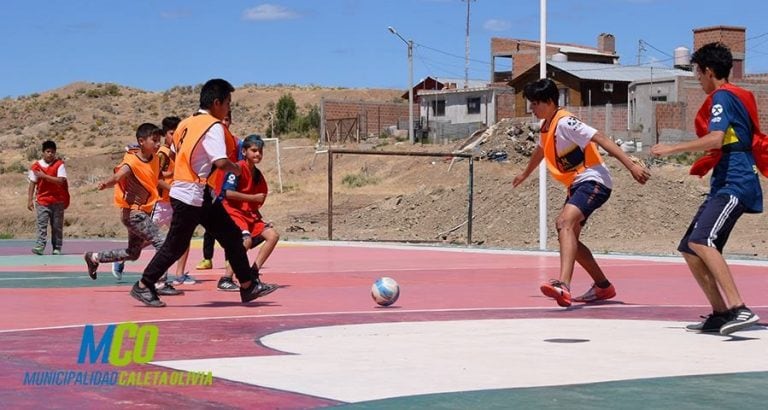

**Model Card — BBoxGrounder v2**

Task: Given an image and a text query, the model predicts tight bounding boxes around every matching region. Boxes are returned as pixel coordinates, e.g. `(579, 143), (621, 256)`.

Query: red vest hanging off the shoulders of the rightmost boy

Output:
(690, 83), (768, 177)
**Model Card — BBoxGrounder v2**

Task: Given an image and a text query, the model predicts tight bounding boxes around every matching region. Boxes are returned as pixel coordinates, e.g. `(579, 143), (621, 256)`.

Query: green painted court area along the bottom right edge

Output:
(336, 372), (768, 410)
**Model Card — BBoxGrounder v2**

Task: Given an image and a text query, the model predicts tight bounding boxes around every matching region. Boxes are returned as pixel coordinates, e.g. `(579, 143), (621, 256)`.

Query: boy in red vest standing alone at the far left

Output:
(27, 140), (69, 255)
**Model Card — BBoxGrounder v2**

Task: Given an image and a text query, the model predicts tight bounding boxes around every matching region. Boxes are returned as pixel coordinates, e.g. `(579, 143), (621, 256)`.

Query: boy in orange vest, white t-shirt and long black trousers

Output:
(130, 78), (277, 307)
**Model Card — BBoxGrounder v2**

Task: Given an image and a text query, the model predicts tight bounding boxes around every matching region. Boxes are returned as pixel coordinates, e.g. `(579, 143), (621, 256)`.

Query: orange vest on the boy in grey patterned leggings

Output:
(114, 152), (160, 214)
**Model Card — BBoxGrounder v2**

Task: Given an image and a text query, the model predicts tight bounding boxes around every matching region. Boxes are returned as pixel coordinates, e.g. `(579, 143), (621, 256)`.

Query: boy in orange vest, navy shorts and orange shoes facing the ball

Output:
(512, 79), (650, 307)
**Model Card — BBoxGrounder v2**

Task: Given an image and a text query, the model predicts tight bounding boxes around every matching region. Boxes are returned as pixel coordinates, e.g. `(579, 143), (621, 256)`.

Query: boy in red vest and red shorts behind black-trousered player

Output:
(218, 135), (280, 290)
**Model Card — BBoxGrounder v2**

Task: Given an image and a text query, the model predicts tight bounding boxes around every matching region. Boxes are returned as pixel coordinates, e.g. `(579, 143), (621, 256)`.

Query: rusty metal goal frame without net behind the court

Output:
(328, 147), (475, 245)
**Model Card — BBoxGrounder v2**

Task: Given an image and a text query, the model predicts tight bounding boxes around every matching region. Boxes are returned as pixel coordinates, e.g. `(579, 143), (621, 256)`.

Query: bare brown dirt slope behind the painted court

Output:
(0, 83), (768, 258)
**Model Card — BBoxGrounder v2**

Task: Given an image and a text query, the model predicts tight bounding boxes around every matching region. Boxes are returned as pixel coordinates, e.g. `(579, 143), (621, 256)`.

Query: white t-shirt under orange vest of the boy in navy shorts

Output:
(539, 116), (613, 189)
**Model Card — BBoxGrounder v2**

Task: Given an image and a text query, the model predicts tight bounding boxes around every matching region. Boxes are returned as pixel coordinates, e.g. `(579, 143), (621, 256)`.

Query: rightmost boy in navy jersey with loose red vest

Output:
(651, 43), (763, 335)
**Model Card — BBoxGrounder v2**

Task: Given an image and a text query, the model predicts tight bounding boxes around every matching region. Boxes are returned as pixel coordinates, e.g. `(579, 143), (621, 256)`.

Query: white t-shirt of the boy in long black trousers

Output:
(168, 110), (227, 206)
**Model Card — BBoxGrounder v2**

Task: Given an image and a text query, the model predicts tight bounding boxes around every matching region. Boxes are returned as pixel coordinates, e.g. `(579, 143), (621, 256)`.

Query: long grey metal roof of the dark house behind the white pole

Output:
(547, 60), (693, 82)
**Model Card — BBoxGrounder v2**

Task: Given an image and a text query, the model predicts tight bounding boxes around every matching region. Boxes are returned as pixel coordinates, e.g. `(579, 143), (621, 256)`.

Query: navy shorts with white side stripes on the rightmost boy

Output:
(677, 195), (744, 255)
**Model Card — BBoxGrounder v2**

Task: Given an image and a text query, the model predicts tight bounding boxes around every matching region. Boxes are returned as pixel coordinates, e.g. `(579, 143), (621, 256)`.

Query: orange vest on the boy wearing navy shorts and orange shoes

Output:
(541, 108), (603, 186)
